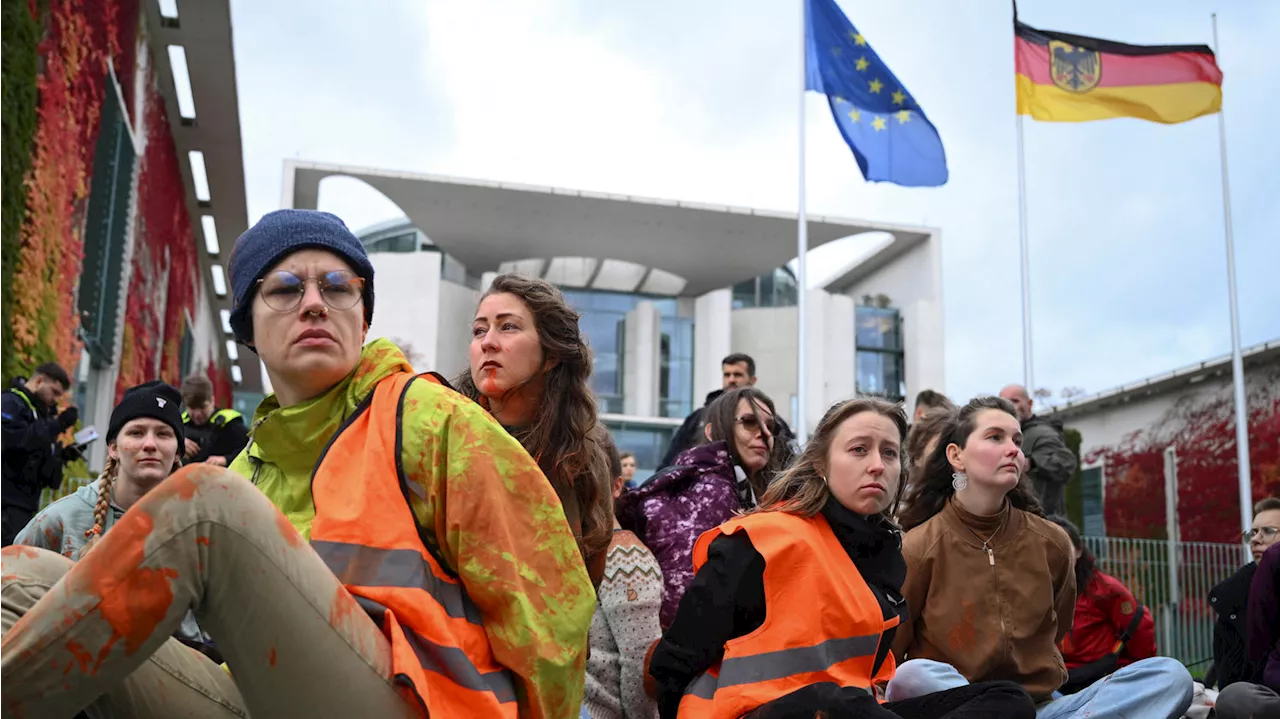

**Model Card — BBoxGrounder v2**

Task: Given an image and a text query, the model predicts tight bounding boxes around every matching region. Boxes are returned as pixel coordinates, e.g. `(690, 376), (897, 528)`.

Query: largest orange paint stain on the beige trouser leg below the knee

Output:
(68, 506), (178, 673)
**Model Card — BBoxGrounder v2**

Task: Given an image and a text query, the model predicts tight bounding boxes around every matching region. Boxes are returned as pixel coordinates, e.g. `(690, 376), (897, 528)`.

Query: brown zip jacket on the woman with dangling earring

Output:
(893, 499), (1075, 702)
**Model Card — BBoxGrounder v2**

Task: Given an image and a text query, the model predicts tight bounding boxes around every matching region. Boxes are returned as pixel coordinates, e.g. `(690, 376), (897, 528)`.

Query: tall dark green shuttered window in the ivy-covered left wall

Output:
(78, 74), (136, 367)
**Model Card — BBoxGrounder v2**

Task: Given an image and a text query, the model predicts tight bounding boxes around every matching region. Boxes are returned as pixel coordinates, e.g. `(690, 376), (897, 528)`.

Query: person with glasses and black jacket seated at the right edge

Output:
(1204, 496), (1280, 690)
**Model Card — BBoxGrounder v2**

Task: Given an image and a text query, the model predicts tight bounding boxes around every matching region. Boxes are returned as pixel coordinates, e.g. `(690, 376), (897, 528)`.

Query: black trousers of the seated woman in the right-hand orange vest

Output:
(746, 682), (1036, 719)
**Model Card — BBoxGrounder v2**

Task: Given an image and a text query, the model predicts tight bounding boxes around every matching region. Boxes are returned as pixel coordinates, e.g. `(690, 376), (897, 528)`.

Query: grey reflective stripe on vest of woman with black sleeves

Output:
(685, 635), (881, 700)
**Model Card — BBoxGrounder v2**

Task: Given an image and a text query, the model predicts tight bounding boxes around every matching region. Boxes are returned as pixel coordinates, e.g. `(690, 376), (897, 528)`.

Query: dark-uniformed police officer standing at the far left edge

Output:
(0, 362), (79, 546)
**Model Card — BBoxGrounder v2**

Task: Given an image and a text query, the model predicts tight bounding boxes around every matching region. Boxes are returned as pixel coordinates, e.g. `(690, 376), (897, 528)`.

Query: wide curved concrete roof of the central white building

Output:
(283, 160), (934, 294)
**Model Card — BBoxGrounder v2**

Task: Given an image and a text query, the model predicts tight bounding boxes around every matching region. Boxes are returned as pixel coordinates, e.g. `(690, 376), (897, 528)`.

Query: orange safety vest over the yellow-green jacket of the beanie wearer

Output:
(311, 372), (517, 719)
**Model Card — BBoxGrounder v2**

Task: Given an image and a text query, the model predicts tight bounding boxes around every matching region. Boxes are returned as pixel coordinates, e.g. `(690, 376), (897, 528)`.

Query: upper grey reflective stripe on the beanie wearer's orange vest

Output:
(311, 540), (481, 624)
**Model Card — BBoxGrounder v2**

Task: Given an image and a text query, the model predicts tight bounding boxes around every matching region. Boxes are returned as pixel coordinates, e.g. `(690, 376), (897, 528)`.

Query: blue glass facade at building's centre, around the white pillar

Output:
(562, 289), (694, 417)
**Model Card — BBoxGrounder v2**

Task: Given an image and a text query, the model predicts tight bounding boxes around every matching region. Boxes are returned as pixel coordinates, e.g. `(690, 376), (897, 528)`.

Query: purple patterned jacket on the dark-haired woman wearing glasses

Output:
(617, 441), (742, 628)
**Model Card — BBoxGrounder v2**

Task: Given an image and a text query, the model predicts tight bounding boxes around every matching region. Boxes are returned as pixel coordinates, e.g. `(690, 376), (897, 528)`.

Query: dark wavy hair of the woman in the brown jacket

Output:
(899, 397), (1044, 531)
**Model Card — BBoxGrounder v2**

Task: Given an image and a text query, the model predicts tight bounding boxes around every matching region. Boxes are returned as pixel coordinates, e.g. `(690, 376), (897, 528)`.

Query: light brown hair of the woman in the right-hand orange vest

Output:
(759, 397), (906, 523)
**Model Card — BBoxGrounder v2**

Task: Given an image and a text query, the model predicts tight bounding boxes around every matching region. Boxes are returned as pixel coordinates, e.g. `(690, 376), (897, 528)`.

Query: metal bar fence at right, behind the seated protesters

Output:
(1084, 537), (1244, 670)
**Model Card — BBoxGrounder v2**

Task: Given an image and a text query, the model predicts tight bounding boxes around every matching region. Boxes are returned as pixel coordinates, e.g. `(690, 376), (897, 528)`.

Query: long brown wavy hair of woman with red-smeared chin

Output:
(453, 273), (613, 565)
